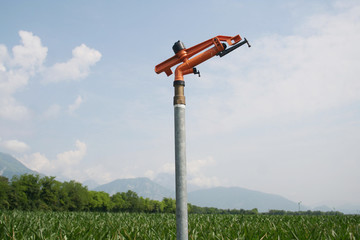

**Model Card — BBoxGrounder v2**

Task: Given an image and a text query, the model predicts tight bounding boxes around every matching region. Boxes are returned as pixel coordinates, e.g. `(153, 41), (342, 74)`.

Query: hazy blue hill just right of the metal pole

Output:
(188, 187), (298, 212)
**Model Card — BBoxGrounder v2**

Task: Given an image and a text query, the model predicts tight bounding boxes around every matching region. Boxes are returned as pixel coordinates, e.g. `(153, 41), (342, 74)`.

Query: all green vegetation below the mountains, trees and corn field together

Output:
(0, 174), (360, 240)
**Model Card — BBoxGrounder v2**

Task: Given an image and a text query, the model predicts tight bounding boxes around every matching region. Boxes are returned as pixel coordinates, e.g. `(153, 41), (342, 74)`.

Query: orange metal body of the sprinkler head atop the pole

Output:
(155, 35), (241, 81)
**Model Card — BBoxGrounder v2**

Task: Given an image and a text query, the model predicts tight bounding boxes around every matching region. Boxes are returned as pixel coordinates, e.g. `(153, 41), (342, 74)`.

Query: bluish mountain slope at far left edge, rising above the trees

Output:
(0, 152), (42, 180)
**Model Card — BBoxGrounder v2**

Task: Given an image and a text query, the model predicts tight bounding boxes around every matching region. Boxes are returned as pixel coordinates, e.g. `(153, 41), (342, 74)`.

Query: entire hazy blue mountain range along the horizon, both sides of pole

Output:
(0, 152), (360, 214)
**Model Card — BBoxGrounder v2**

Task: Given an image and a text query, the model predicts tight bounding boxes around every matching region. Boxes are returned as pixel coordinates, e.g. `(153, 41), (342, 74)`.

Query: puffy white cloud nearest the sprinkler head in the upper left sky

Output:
(44, 44), (101, 82)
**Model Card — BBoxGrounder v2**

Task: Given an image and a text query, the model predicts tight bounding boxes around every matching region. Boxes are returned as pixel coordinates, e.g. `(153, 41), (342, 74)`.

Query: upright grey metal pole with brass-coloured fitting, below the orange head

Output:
(174, 81), (188, 240)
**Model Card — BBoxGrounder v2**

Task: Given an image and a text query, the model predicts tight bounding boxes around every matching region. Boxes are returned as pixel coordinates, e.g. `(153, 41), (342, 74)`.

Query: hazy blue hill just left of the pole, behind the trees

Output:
(93, 178), (175, 200)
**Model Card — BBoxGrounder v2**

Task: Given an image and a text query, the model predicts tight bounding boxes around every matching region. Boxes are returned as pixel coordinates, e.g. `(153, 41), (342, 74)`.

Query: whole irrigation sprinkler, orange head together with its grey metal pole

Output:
(155, 35), (250, 240)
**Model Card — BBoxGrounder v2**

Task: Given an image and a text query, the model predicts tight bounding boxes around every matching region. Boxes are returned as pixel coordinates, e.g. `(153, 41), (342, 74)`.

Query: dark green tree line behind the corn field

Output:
(0, 174), (344, 215)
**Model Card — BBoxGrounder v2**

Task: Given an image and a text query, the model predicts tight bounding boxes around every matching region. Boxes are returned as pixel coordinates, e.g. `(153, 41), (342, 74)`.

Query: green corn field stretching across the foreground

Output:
(0, 211), (360, 240)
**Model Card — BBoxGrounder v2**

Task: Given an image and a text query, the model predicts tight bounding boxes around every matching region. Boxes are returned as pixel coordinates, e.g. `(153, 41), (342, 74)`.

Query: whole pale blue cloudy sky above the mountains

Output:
(0, 0), (360, 207)
